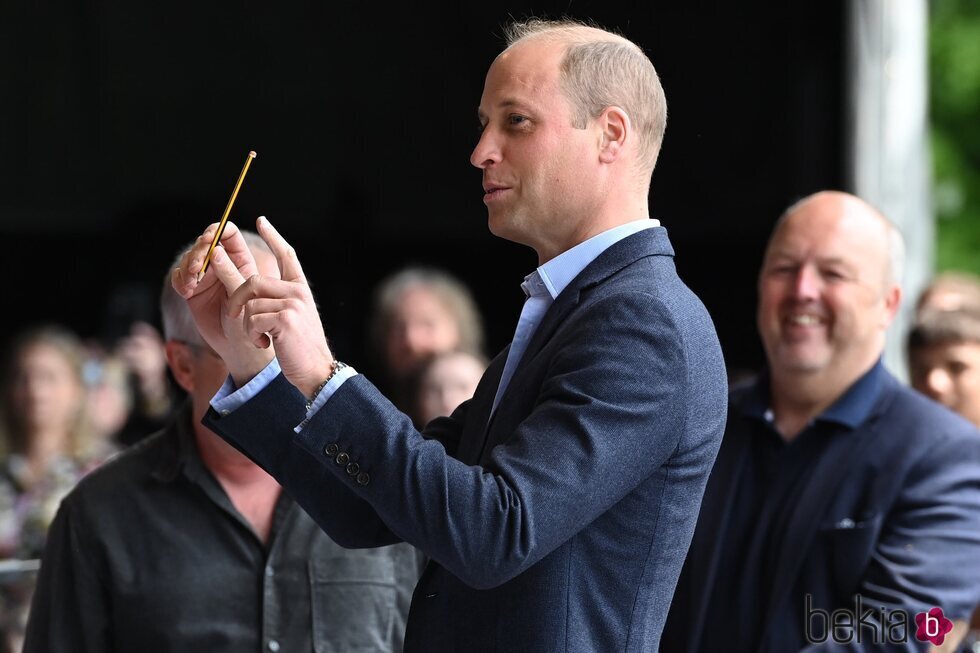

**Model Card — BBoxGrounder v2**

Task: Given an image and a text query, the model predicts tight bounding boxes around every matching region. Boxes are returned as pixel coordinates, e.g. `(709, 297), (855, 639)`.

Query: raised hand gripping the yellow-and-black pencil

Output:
(171, 222), (274, 386)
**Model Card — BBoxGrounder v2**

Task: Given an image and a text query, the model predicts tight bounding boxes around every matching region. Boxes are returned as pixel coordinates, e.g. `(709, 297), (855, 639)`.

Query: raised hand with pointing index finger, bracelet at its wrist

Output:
(226, 217), (334, 397)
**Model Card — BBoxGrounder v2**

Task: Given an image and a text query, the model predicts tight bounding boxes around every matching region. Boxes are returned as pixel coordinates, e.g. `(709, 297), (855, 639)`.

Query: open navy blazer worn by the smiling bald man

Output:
(662, 368), (980, 653)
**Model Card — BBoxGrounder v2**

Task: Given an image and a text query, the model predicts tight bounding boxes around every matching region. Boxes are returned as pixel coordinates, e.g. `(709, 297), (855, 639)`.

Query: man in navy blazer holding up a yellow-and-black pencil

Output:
(174, 17), (727, 653)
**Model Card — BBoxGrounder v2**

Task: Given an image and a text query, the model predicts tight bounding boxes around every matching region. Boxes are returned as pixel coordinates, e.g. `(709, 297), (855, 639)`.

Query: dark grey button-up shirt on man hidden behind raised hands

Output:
(25, 402), (421, 653)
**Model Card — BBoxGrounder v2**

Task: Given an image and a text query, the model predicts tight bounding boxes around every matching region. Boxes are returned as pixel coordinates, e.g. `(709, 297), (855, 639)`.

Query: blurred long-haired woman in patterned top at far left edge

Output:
(0, 326), (110, 650)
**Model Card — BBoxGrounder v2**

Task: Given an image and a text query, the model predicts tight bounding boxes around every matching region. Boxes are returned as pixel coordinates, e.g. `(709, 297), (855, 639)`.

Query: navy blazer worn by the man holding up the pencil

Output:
(205, 228), (727, 653)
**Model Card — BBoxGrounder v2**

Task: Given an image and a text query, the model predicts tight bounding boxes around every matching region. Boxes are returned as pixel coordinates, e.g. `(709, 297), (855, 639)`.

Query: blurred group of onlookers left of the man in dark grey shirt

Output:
(0, 323), (177, 650)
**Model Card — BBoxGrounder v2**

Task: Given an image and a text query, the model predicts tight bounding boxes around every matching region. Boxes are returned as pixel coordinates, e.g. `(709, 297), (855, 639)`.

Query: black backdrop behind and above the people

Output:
(0, 0), (847, 368)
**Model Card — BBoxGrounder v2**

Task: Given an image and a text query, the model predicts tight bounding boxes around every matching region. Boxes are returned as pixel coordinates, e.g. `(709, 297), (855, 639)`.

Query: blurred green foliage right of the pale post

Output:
(929, 0), (980, 274)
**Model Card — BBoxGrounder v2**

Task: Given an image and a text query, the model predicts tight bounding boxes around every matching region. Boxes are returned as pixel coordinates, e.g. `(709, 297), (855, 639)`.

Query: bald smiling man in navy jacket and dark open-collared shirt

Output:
(662, 192), (980, 653)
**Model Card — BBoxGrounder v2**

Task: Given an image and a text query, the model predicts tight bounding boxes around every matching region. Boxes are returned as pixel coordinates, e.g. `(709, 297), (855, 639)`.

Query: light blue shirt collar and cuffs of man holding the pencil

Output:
(211, 219), (660, 433)
